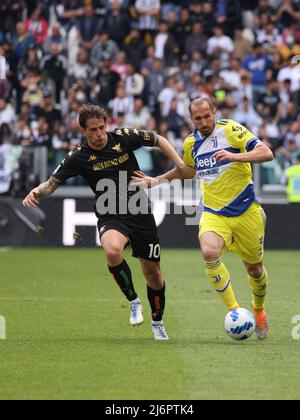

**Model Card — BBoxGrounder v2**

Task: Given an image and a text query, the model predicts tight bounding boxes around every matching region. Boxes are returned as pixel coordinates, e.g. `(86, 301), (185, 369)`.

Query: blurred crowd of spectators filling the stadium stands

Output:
(0, 0), (300, 194)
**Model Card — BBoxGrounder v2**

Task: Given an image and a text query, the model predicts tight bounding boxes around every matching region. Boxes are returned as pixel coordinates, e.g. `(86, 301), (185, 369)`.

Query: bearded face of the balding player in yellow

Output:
(191, 102), (216, 137)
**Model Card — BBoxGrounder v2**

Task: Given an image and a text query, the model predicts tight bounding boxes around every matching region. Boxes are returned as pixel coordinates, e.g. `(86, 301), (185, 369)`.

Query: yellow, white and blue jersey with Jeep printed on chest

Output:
(184, 120), (261, 217)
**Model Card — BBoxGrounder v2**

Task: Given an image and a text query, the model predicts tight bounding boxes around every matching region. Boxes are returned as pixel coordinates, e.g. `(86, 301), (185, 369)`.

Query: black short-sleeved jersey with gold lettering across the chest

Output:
(52, 128), (158, 215)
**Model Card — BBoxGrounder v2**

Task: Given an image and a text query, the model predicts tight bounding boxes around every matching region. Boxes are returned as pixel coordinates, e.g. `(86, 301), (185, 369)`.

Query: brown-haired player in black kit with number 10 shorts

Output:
(23, 105), (184, 340)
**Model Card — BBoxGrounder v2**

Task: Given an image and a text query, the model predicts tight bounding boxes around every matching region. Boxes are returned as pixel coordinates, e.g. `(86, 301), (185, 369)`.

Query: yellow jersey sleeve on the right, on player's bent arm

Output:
(226, 121), (262, 152)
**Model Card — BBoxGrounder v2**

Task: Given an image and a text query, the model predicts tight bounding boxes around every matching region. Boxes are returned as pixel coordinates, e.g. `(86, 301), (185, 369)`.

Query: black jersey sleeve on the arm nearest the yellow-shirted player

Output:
(115, 128), (159, 151)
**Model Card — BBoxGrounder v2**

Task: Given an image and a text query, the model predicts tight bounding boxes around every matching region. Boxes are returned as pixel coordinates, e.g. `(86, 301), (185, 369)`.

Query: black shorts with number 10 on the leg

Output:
(98, 214), (160, 262)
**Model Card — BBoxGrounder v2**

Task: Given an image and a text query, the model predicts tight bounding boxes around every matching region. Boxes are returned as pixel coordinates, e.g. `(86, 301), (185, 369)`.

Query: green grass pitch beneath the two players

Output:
(0, 249), (300, 400)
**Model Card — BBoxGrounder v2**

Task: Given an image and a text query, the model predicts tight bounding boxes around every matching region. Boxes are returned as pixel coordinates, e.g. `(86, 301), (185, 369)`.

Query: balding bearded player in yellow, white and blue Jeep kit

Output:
(135, 98), (273, 339)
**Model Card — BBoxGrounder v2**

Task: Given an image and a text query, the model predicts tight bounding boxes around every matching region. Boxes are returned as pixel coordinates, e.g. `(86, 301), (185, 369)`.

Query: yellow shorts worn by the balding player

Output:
(199, 203), (267, 264)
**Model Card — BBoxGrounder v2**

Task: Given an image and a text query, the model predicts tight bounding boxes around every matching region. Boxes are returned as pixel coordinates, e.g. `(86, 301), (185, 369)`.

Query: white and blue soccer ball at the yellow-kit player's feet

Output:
(224, 308), (256, 341)
